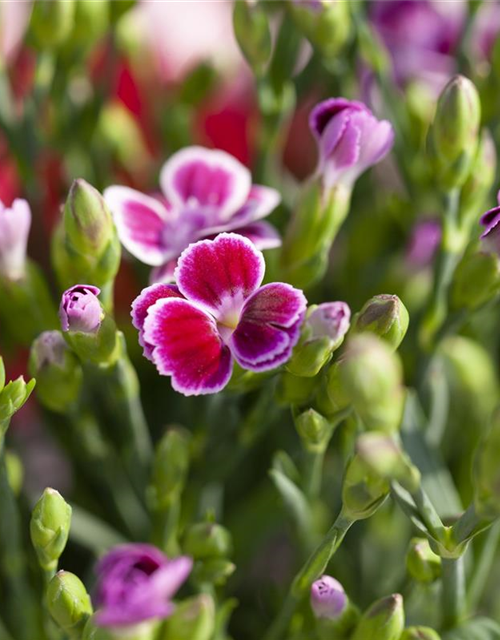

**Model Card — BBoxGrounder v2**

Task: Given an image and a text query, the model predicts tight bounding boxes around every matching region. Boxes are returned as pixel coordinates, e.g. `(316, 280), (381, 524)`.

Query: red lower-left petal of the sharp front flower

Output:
(144, 298), (232, 396)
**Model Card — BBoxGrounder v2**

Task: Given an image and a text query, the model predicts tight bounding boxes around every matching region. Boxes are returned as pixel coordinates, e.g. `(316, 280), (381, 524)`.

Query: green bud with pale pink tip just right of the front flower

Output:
(286, 302), (351, 377)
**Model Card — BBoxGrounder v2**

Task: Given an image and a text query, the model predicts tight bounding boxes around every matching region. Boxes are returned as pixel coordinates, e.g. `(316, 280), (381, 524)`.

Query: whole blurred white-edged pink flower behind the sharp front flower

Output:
(104, 147), (281, 282)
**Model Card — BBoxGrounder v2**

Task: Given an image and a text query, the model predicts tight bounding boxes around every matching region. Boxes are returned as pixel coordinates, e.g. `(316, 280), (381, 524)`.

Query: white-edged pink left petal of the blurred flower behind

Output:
(104, 186), (173, 266)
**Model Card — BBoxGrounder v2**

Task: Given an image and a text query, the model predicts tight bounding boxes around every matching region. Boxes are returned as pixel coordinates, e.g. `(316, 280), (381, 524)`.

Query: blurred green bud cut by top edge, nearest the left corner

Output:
(30, 0), (75, 49)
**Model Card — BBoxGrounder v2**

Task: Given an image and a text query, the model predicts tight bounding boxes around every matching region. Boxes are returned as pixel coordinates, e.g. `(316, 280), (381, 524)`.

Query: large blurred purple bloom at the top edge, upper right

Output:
(370, 0), (468, 91)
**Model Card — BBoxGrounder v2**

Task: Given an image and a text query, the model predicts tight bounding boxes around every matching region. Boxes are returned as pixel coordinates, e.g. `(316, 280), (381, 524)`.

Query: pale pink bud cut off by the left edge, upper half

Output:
(0, 200), (31, 280)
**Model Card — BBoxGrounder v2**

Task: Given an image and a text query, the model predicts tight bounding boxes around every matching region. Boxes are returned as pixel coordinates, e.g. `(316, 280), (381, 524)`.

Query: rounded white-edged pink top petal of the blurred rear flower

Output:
(160, 147), (251, 220)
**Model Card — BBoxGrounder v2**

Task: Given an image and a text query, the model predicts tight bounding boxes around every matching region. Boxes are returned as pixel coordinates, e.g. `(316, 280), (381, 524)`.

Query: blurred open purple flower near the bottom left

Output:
(95, 543), (193, 627)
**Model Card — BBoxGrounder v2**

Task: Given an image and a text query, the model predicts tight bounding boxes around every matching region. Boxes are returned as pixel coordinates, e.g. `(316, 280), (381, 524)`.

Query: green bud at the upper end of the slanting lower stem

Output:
(342, 455), (390, 520)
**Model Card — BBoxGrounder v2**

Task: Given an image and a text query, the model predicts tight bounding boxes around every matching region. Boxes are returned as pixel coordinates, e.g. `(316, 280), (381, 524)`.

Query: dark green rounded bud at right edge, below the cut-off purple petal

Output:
(451, 253), (500, 311)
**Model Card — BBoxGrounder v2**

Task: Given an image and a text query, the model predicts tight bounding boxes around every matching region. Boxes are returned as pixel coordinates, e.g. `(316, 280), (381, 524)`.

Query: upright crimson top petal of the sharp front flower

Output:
(175, 233), (265, 320)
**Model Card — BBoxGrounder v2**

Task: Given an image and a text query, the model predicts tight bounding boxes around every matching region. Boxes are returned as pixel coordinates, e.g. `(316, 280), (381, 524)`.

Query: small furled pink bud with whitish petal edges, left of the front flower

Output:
(59, 284), (104, 333)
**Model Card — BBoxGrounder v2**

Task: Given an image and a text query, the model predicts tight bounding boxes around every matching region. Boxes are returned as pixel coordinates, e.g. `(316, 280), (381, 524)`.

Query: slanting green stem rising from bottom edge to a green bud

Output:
(264, 511), (355, 640)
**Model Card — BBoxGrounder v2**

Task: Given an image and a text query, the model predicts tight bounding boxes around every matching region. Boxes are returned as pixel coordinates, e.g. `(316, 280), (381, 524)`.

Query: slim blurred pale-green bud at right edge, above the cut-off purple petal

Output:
(459, 129), (497, 230)
